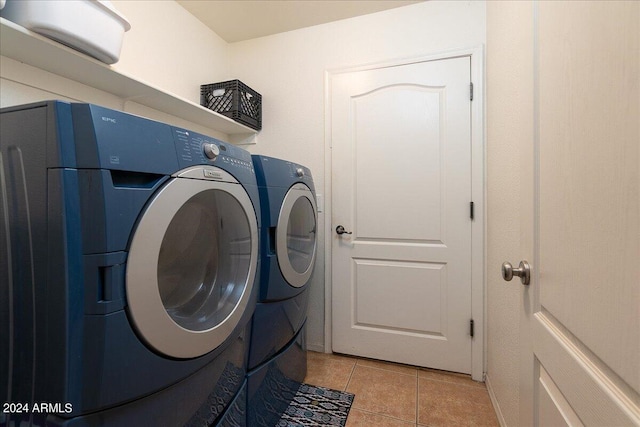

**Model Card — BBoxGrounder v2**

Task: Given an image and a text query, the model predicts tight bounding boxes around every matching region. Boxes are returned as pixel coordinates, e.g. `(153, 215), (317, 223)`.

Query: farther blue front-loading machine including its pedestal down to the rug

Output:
(247, 156), (318, 425)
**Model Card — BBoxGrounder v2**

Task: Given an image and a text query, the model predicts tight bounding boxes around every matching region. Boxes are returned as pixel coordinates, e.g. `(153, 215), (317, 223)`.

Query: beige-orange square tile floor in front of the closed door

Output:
(305, 351), (499, 427)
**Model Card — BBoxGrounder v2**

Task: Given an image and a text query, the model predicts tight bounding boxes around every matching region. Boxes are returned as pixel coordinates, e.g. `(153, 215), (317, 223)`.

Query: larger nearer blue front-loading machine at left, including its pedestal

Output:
(0, 101), (261, 426)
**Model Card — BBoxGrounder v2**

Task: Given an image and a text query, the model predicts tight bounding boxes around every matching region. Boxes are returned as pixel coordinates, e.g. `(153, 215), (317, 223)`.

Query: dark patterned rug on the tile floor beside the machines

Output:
(276, 384), (355, 427)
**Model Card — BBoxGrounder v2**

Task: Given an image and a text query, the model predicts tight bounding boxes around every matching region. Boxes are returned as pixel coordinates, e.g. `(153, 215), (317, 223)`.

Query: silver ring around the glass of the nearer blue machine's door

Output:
(126, 172), (258, 358)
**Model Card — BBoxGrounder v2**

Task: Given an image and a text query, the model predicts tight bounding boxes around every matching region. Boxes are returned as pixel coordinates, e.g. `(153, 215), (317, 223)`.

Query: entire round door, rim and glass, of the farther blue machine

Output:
(276, 184), (318, 288)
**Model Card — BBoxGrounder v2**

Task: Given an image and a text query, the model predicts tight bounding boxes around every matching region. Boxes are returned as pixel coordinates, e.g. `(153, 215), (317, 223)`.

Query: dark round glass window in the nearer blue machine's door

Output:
(158, 190), (251, 331)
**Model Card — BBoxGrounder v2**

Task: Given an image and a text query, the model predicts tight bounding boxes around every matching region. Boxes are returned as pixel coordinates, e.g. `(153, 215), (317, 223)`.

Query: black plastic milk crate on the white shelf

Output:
(200, 80), (262, 130)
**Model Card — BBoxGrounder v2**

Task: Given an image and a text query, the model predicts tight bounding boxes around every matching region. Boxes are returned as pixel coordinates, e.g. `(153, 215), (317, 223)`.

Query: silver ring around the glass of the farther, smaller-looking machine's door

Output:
(276, 184), (318, 288)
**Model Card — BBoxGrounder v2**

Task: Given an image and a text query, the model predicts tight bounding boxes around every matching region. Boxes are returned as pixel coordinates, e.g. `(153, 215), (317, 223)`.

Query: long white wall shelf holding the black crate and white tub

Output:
(0, 18), (257, 138)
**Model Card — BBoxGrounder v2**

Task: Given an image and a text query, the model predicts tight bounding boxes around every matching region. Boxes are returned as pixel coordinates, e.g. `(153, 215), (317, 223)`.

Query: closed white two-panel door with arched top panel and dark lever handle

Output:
(330, 56), (472, 373)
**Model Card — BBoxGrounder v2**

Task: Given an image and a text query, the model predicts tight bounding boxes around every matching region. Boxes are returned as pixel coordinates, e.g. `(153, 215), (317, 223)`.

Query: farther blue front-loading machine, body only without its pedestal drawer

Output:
(249, 155), (318, 369)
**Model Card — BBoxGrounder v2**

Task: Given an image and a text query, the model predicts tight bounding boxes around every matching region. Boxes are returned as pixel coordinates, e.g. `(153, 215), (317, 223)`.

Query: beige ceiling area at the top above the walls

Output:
(177, 0), (424, 43)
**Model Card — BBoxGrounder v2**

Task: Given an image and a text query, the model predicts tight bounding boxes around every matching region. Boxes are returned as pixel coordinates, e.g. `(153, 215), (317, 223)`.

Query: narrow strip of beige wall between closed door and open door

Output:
(486, 1), (533, 426)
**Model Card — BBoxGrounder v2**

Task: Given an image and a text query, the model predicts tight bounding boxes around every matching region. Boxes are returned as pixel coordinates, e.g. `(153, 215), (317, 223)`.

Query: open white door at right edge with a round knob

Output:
(510, 2), (640, 426)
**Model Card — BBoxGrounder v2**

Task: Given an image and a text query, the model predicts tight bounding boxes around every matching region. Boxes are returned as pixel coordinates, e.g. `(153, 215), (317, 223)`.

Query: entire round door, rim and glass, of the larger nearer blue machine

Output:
(126, 167), (258, 358)
